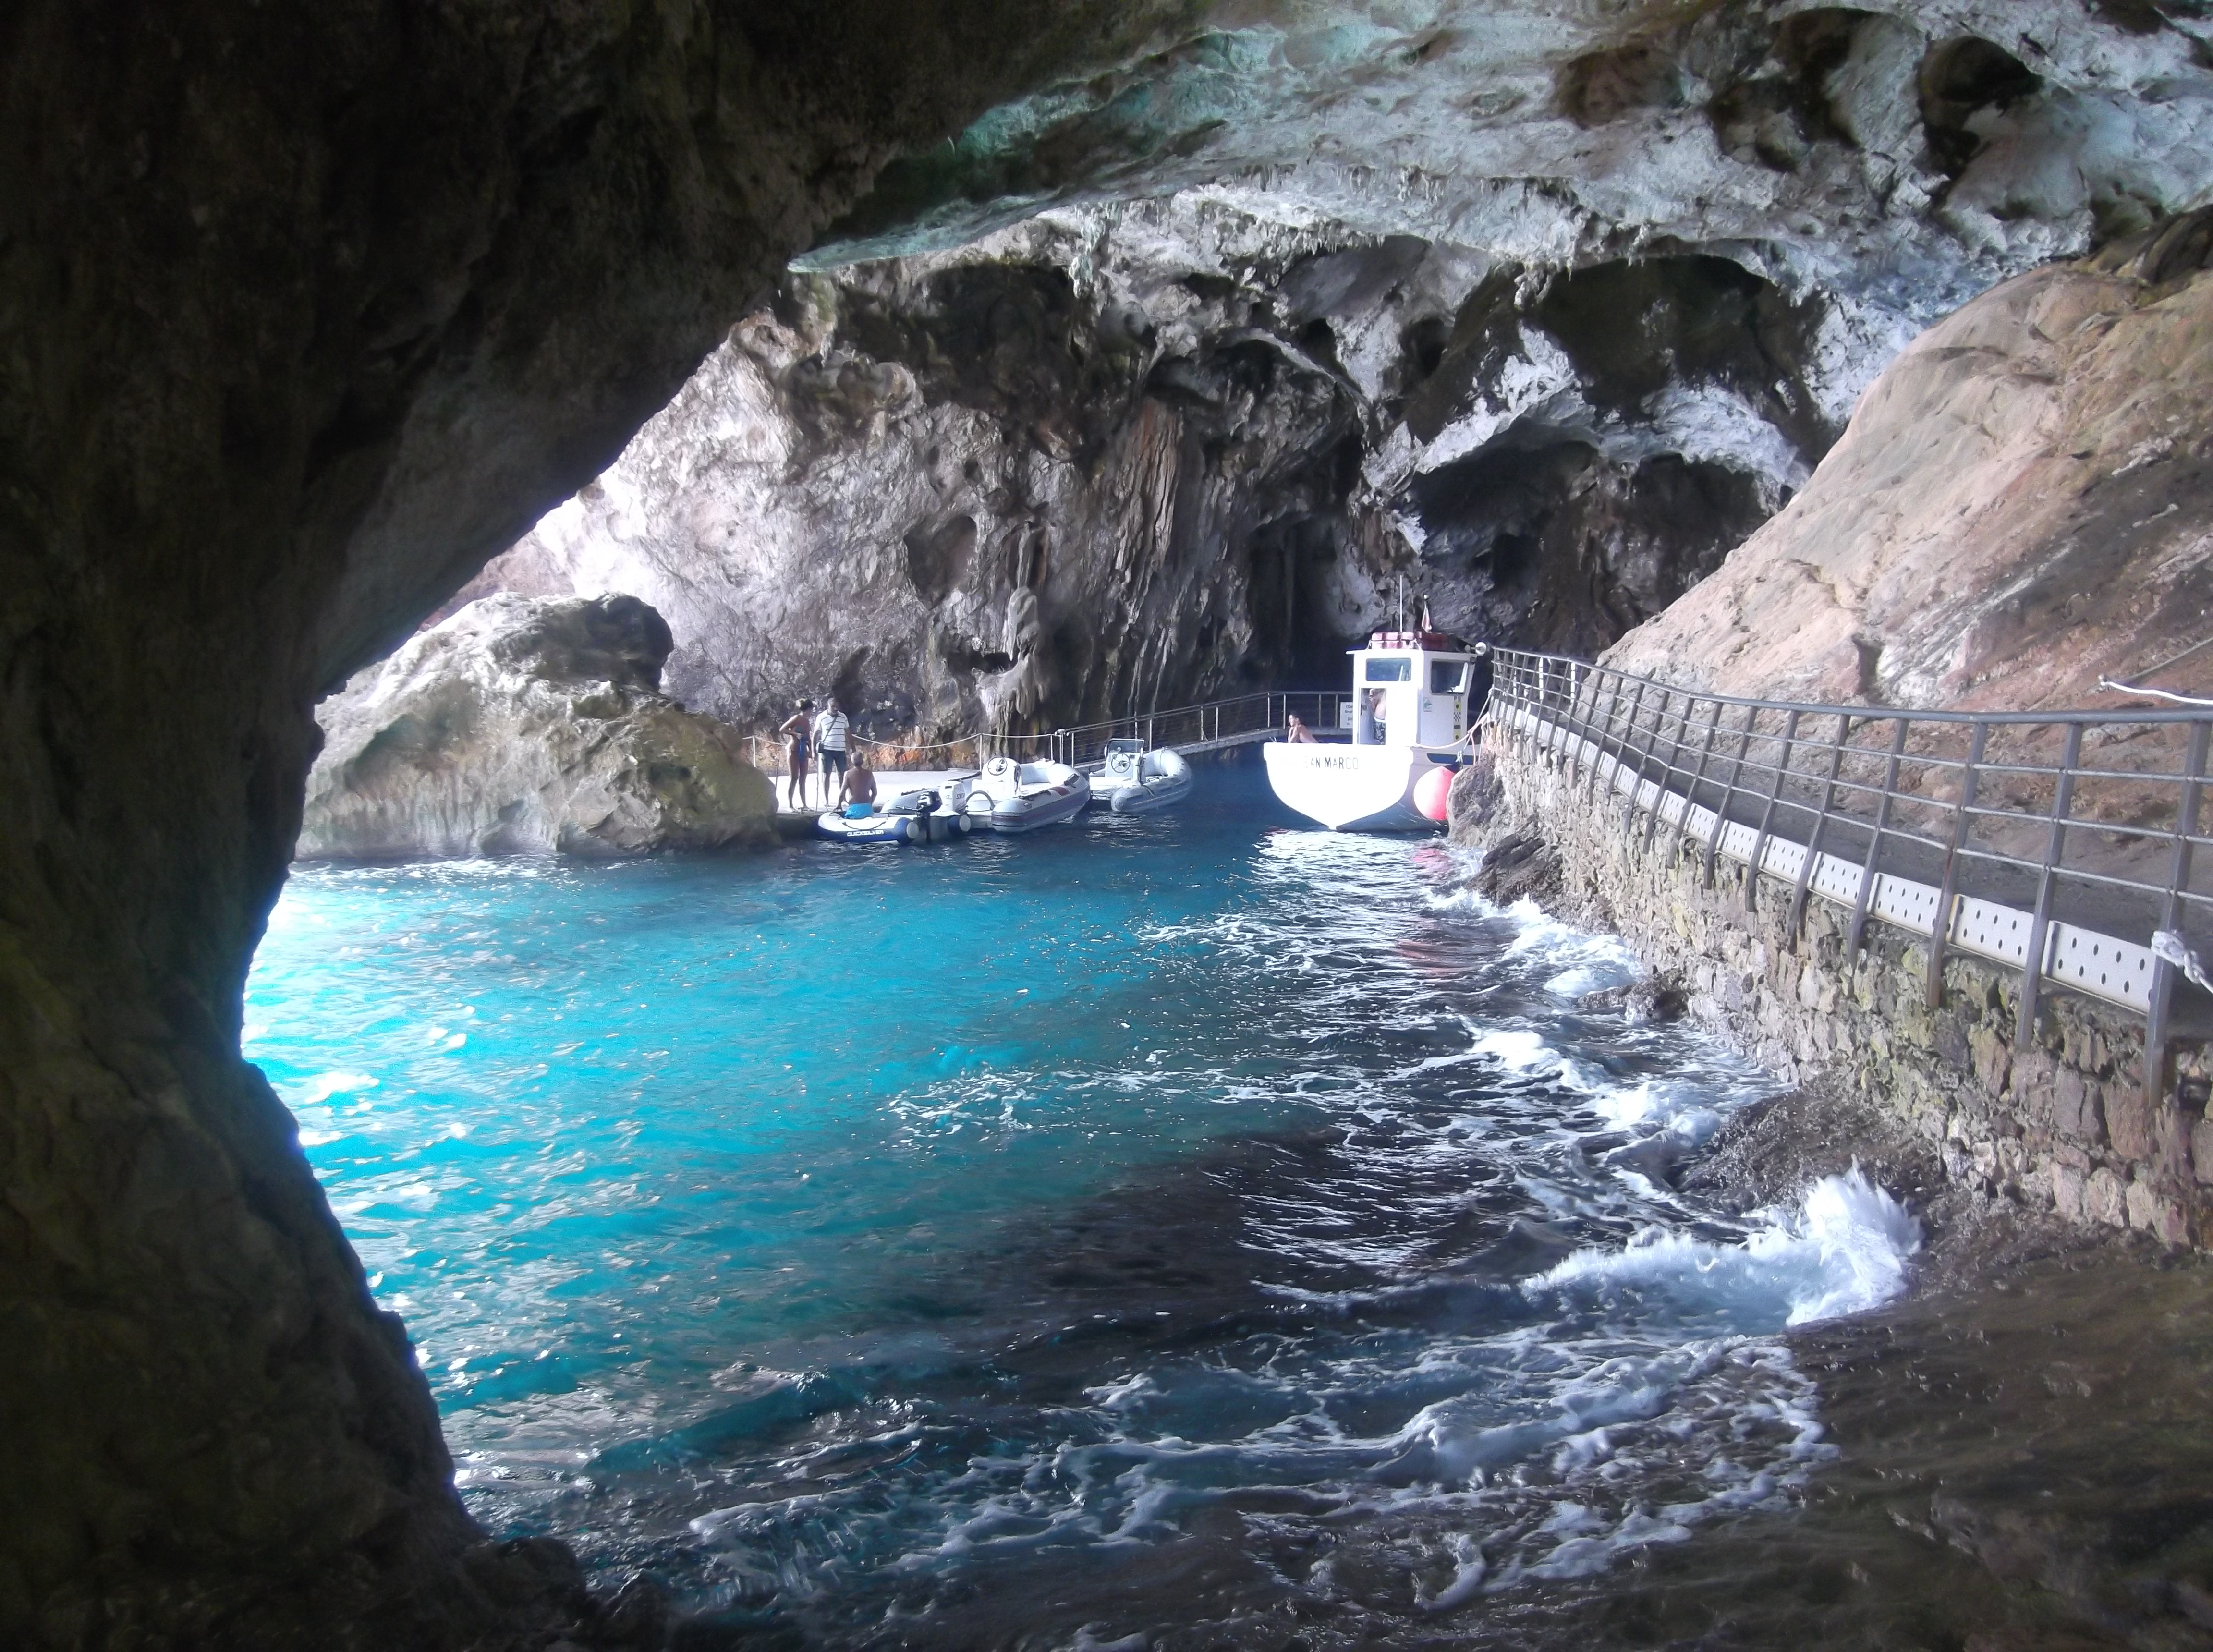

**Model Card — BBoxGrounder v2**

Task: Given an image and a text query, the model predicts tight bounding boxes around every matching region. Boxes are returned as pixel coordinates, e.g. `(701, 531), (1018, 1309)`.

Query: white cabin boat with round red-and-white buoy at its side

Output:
(1262, 630), (1476, 832)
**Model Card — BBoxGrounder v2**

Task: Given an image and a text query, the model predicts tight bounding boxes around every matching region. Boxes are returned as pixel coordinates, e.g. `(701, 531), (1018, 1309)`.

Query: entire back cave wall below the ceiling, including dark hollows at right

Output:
(472, 201), (1797, 739)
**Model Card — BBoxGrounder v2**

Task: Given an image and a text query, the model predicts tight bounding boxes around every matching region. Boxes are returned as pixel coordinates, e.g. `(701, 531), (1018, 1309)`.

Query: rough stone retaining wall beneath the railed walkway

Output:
(1454, 729), (2213, 1245)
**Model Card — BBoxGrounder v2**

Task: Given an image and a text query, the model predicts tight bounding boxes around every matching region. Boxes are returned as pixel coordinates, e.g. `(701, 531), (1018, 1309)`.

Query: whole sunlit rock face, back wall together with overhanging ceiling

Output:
(478, 2), (2213, 739)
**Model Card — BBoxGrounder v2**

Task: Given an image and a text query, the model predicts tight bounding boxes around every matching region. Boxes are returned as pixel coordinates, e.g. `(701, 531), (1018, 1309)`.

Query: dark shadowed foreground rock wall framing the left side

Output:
(0, 0), (1195, 1650)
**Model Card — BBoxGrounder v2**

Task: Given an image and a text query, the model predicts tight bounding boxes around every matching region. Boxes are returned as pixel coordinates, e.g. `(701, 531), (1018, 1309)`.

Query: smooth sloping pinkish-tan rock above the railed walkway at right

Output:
(1606, 212), (2213, 710)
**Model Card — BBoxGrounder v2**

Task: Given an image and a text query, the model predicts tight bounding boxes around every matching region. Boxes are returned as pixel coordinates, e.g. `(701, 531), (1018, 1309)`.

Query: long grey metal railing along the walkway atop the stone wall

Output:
(1485, 650), (2213, 1095)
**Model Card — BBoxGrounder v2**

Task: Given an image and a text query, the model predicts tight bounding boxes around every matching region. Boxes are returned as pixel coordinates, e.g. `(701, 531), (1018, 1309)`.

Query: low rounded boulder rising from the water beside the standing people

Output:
(299, 595), (777, 860)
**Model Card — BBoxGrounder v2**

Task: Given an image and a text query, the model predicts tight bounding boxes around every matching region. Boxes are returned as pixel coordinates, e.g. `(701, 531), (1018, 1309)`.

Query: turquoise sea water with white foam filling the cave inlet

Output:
(245, 772), (1917, 1648)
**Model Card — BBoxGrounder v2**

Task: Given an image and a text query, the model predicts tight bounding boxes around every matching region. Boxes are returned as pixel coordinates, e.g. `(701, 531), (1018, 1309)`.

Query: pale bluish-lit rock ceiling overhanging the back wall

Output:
(801, 0), (2213, 301)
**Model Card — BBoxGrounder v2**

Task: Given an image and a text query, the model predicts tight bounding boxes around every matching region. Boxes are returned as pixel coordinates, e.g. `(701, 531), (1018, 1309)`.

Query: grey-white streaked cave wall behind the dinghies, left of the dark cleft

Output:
(465, 234), (1357, 739)
